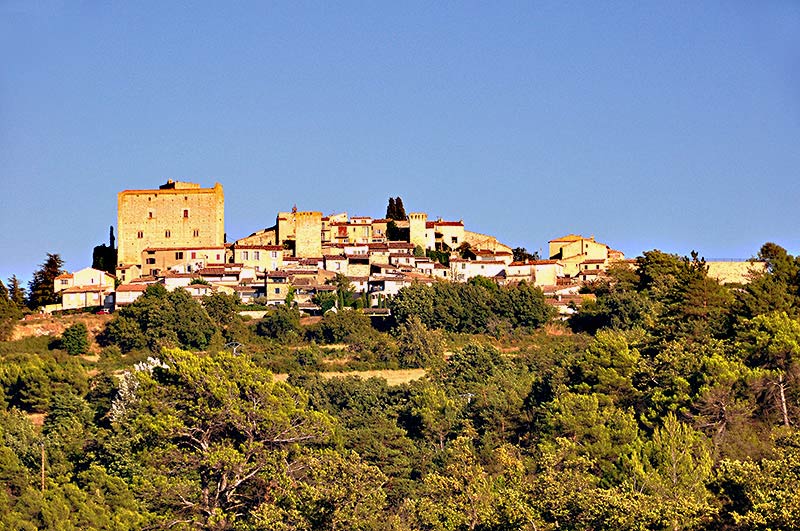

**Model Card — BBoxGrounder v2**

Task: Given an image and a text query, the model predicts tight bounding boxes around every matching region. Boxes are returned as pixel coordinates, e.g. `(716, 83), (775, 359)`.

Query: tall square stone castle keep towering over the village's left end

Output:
(117, 180), (225, 267)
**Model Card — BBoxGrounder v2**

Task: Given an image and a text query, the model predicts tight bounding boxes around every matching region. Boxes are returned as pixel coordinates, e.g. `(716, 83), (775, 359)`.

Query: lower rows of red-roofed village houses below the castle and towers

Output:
(50, 235), (621, 314)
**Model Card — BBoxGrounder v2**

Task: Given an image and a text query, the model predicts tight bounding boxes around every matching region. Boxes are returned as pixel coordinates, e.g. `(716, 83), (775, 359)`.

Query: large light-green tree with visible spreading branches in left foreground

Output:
(112, 350), (332, 530)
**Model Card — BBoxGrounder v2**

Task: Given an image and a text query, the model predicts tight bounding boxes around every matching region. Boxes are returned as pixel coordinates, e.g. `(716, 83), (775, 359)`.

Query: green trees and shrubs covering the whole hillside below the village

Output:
(0, 244), (800, 531)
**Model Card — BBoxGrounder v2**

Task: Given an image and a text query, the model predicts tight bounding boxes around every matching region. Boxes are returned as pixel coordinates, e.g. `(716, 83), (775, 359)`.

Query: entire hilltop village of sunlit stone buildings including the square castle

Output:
(45, 180), (752, 314)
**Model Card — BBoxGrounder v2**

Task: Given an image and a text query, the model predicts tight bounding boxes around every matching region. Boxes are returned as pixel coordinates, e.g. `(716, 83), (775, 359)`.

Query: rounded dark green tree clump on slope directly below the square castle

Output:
(106, 284), (218, 352)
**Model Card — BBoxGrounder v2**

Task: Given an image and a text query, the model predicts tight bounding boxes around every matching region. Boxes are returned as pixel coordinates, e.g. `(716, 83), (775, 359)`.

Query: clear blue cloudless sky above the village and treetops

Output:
(0, 0), (800, 283)
